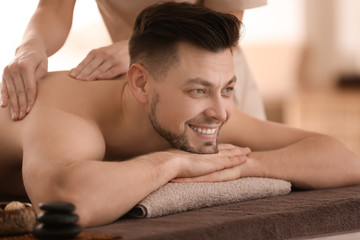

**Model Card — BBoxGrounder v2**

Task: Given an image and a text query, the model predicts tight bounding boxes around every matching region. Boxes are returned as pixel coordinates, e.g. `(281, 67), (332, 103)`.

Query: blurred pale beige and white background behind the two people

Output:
(0, 0), (360, 154)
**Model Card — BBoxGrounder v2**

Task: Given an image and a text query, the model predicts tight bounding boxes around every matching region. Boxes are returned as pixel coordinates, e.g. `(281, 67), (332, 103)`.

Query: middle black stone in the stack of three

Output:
(37, 212), (79, 226)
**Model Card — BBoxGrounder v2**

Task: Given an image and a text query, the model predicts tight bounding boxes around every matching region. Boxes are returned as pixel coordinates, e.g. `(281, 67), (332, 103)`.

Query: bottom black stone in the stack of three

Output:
(33, 223), (81, 239)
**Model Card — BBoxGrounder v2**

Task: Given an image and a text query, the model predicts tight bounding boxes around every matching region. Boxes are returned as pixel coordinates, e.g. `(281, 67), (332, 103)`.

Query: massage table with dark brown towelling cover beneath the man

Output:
(84, 186), (360, 240)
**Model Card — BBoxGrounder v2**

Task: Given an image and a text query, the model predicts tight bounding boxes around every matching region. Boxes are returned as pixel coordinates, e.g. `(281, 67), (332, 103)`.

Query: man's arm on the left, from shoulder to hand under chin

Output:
(23, 109), (248, 226)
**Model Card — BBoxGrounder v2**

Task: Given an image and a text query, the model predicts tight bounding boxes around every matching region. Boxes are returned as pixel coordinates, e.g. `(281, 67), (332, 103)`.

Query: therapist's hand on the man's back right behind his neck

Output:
(70, 40), (130, 81)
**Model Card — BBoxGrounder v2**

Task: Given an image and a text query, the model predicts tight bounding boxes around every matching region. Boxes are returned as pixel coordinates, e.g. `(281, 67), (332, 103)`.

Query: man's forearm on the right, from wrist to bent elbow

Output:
(243, 135), (360, 189)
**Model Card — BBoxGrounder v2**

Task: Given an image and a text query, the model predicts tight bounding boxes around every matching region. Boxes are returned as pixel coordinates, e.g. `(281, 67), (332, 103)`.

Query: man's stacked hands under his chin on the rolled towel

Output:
(172, 144), (251, 182)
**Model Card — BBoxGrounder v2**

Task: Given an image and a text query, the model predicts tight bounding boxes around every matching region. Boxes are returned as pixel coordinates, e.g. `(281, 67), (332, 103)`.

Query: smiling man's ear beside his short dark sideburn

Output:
(127, 63), (149, 103)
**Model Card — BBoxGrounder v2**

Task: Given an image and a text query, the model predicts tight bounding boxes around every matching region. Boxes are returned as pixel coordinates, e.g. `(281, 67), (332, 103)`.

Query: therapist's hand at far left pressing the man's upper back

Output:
(1, 42), (48, 121)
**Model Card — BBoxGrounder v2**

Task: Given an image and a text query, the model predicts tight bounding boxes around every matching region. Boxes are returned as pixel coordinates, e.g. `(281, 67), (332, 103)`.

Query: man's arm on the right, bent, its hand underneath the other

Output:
(175, 109), (360, 188)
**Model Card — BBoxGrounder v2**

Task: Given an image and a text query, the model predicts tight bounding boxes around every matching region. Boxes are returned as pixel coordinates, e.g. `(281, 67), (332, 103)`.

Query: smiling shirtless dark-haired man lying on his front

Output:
(0, 3), (360, 226)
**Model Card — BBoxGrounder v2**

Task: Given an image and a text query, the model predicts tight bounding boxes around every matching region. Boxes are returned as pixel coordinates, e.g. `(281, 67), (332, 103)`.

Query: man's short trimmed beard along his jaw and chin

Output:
(149, 93), (219, 153)
